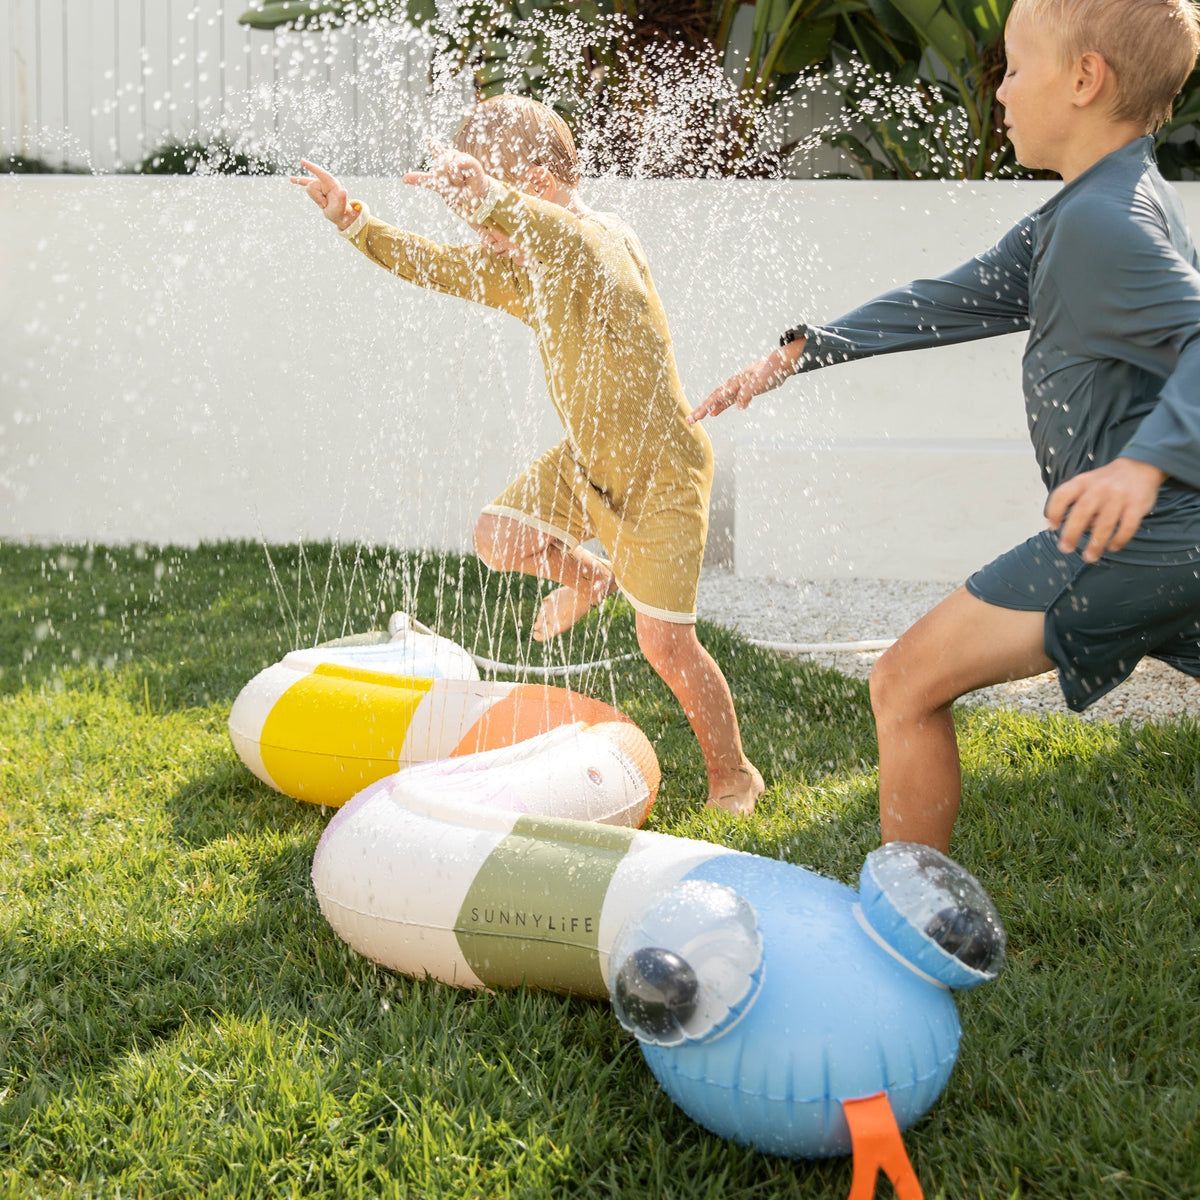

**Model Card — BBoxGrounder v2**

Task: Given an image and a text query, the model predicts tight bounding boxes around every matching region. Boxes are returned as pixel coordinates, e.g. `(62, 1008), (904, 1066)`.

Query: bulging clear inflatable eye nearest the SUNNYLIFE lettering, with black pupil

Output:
(608, 880), (763, 1046)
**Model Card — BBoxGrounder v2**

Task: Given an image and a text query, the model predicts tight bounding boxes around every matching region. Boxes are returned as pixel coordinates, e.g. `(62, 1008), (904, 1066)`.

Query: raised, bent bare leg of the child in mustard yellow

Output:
(475, 512), (617, 642)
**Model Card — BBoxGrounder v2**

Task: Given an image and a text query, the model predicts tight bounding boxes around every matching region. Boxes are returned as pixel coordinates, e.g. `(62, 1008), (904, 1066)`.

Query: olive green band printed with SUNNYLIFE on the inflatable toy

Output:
(455, 816), (637, 997)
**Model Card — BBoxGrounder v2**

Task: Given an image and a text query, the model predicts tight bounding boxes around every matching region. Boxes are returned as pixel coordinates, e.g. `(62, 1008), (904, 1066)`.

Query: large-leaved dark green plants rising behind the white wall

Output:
(240, 0), (1200, 179)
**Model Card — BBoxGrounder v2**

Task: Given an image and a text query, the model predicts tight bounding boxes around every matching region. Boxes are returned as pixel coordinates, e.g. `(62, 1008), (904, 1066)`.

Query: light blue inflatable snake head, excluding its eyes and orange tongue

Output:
(642, 854), (960, 1158)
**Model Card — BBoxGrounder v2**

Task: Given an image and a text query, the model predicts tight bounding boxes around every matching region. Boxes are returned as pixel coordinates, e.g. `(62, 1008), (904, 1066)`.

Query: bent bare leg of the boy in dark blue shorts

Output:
(871, 587), (1054, 853)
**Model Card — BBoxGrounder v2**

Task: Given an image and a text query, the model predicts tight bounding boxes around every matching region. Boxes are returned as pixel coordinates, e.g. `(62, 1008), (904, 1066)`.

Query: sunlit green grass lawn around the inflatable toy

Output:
(0, 545), (1200, 1200)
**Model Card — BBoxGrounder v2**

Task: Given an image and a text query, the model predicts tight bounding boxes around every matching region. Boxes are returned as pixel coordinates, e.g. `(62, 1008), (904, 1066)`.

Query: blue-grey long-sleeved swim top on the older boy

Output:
(786, 138), (1200, 563)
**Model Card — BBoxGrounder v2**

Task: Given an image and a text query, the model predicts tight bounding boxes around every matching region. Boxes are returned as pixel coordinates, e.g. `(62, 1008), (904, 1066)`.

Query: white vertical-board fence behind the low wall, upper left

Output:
(0, 0), (446, 172)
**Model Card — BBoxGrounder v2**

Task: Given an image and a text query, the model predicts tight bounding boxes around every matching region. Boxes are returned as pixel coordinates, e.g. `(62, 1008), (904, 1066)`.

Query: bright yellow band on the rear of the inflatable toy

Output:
(259, 662), (433, 805)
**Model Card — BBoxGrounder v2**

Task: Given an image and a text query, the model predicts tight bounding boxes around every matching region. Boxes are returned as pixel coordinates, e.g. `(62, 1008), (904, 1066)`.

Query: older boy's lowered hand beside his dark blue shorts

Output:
(1045, 458), (1166, 563)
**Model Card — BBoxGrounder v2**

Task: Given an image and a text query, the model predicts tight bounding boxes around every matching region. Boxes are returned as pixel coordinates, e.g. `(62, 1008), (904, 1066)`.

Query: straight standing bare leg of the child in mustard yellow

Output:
(636, 612), (763, 814)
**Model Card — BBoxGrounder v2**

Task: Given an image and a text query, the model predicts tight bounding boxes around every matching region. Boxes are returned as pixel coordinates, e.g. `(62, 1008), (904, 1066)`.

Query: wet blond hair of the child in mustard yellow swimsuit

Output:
(452, 96), (580, 187)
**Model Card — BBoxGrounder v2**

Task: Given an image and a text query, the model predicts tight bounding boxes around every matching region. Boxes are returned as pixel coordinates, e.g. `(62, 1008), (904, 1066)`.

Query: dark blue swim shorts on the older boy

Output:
(966, 530), (1200, 713)
